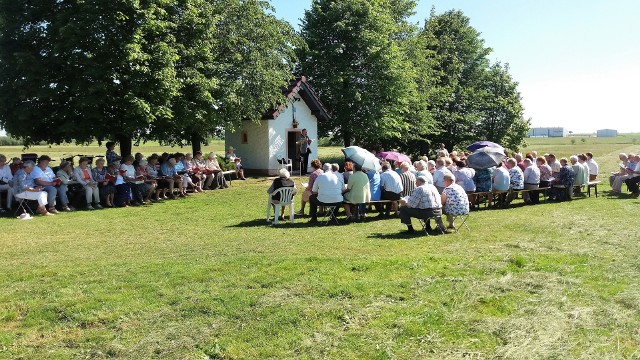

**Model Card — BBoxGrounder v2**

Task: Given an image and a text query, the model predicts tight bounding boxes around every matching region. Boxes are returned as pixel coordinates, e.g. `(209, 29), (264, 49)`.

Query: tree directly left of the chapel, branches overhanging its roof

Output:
(156, 0), (300, 151)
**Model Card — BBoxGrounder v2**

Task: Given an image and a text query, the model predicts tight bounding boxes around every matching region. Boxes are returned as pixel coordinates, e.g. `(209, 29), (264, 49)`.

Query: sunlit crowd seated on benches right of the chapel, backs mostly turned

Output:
(270, 145), (604, 235)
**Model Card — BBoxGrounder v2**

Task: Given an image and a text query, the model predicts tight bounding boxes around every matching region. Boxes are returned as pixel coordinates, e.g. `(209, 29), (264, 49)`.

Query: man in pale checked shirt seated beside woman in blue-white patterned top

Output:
(400, 176), (445, 233)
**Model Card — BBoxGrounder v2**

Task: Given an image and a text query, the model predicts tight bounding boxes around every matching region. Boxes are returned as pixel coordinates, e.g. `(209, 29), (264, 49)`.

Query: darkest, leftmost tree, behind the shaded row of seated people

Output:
(0, 0), (178, 154)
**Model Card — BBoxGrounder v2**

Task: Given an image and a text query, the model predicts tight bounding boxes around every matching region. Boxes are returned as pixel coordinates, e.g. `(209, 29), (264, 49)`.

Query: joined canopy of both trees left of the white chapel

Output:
(0, 0), (299, 154)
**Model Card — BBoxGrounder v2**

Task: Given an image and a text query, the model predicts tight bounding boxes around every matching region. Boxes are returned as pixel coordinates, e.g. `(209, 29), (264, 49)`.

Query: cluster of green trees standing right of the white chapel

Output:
(299, 0), (529, 154)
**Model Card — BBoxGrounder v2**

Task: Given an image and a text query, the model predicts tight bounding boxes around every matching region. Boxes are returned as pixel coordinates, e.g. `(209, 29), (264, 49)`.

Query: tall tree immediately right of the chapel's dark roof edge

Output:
(299, 0), (428, 147)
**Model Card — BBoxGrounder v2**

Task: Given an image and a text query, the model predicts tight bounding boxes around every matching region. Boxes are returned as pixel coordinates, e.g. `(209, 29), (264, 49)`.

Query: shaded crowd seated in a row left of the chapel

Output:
(0, 142), (244, 215)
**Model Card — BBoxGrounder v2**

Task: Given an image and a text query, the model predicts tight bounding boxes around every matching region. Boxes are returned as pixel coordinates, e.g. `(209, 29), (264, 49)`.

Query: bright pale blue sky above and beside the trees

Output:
(271, 0), (640, 132)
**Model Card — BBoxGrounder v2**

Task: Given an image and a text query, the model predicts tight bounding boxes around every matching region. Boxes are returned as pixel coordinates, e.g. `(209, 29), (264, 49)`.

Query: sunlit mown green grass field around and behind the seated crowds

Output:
(0, 136), (640, 359)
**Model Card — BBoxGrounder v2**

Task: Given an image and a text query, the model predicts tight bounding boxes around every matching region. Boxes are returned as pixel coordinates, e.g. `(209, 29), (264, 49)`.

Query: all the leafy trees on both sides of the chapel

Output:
(0, 0), (528, 154)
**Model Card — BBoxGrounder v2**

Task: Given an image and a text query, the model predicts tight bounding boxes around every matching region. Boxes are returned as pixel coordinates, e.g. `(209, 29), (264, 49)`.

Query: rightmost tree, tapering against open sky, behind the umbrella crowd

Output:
(420, 10), (530, 150)
